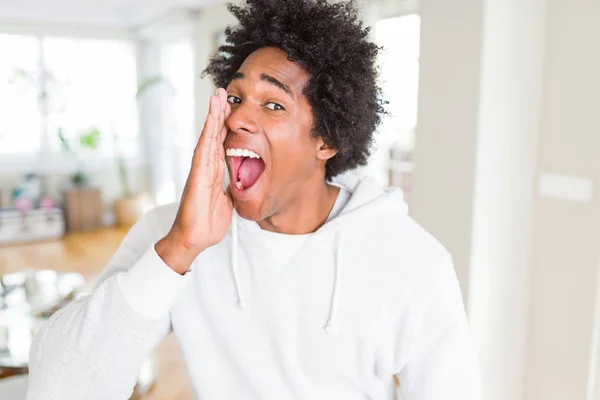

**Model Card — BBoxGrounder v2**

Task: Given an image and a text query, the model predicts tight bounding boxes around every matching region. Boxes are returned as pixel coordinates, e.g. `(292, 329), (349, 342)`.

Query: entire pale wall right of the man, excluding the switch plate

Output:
(413, 0), (600, 400)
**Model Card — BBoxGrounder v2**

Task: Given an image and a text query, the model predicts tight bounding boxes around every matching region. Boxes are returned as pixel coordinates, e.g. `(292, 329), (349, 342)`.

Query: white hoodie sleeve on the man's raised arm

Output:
(27, 211), (190, 400)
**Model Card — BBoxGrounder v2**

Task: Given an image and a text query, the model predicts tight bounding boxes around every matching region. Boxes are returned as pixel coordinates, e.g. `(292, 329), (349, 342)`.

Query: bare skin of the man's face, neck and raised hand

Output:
(155, 47), (339, 274)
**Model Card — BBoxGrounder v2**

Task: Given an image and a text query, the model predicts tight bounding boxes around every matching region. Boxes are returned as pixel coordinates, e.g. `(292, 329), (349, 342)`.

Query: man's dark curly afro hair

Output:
(203, 0), (385, 180)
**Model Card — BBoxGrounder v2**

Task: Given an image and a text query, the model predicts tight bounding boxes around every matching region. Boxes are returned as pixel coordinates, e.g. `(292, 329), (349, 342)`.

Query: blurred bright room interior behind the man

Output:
(0, 0), (600, 400)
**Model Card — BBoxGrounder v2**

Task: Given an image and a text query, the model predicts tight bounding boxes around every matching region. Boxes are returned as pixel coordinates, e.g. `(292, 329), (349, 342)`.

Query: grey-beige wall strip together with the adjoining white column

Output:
(413, 0), (545, 400)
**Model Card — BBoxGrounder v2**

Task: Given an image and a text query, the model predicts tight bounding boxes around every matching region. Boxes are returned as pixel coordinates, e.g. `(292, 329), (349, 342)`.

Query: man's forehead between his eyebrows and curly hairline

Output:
(237, 47), (309, 93)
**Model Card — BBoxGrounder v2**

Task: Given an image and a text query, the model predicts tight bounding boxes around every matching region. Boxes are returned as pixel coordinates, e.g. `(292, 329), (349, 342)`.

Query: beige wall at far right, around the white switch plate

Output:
(526, 0), (600, 400)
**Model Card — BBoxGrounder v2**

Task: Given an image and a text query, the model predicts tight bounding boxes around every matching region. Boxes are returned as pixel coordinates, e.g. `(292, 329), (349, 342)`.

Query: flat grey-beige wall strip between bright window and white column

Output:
(411, 0), (483, 301)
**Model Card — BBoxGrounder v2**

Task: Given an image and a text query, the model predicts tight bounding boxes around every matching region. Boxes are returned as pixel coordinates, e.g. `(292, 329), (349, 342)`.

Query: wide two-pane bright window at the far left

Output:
(0, 34), (140, 167)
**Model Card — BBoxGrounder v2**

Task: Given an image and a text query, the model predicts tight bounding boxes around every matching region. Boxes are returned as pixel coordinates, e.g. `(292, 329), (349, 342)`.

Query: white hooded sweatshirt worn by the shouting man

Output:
(27, 175), (481, 400)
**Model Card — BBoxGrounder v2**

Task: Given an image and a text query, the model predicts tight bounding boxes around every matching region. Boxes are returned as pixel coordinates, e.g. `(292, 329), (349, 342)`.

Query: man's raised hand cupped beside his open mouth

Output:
(155, 89), (233, 274)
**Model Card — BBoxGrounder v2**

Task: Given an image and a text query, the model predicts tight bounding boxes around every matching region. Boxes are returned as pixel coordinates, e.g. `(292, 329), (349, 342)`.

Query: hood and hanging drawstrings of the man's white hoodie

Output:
(231, 173), (408, 334)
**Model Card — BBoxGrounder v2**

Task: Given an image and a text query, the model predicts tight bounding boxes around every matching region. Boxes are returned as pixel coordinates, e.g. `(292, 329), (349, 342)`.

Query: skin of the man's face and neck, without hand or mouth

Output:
(225, 47), (338, 233)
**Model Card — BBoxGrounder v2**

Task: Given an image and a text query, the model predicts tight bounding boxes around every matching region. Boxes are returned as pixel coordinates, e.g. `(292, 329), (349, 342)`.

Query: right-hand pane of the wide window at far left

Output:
(43, 38), (139, 156)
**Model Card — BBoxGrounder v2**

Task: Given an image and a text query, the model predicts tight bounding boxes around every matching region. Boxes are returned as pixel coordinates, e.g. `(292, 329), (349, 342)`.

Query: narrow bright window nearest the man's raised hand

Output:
(140, 36), (197, 205)
